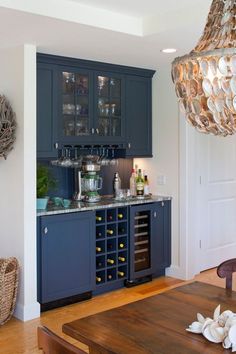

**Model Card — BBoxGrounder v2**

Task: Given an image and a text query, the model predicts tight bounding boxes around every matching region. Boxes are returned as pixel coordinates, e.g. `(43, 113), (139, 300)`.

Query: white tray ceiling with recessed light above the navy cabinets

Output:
(0, 0), (211, 70)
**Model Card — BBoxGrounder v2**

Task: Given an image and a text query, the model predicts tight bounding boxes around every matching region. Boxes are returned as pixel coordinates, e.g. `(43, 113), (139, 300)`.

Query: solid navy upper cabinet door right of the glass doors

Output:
(125, 76), (152, 157)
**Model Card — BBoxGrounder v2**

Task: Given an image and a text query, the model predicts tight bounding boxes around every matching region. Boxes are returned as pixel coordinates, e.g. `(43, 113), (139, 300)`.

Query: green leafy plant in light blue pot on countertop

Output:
(37, 164), (56, 210)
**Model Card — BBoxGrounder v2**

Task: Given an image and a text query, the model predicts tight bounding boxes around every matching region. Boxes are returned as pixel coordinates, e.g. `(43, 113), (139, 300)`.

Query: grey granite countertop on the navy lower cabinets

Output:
(37, 196), (171, 216)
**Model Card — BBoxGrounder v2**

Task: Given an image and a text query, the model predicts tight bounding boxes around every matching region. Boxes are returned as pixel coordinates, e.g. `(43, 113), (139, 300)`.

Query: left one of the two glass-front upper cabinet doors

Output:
(60, 70), (93, 143)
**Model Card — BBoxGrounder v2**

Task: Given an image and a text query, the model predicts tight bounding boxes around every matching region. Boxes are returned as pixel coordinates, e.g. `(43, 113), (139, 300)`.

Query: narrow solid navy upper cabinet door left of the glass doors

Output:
(37, 63), (57, 157)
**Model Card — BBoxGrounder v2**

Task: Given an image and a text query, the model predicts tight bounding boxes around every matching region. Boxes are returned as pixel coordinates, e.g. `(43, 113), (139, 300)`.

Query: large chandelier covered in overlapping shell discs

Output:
(172, 0), (236, 136)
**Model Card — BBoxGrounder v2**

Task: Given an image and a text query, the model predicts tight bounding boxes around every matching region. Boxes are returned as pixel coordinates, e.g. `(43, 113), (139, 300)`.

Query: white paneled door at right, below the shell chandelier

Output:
(196, 133), (236, 271)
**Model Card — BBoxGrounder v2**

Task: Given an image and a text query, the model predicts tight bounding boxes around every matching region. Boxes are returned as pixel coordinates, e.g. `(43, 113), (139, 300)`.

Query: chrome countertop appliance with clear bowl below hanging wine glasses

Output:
(74, 155), (102, 203)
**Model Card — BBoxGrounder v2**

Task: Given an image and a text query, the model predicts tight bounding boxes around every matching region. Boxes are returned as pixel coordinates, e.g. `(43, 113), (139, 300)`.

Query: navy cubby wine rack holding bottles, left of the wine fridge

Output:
(96, 207), (129, 289)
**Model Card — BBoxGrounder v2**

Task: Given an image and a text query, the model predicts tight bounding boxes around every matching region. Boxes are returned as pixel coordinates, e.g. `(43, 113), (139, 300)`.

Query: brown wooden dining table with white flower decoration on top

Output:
(62, 282), (236, 354)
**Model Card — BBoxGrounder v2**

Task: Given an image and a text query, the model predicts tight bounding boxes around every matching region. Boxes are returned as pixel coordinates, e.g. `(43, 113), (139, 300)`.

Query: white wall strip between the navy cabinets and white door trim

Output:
(134, 64), (184, 278)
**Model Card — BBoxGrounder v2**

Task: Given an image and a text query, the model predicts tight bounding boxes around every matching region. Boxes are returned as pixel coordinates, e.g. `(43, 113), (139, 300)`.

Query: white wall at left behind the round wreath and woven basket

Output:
(0, 45), (40, 320)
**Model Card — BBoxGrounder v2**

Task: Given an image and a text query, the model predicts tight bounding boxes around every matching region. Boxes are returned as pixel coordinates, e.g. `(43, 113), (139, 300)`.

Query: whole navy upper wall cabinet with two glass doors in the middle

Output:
(37, 54), (154, 157)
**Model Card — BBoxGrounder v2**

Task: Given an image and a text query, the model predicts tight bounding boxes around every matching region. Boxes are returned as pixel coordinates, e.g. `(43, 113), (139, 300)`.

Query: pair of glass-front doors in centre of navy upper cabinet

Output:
(59, 67), (125, 145)
